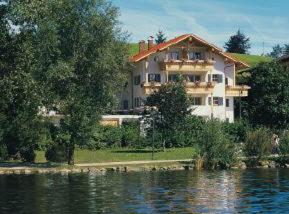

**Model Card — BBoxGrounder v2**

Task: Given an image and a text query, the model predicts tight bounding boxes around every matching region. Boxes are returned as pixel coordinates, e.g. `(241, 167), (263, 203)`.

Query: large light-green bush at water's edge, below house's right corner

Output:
(197, 120), (236, 169)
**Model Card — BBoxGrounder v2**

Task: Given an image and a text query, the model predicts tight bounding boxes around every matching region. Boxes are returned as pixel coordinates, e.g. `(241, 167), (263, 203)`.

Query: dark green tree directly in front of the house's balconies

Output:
(146, 79), (191, 147)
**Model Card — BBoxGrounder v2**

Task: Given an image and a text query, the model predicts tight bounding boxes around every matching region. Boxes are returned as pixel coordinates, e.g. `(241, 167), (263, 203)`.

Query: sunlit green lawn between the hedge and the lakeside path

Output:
(36, 147), (194, 163)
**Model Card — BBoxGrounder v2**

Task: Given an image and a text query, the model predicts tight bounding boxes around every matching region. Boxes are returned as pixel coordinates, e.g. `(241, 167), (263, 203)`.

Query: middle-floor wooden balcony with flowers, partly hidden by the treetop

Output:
(142, 82), (216, 95)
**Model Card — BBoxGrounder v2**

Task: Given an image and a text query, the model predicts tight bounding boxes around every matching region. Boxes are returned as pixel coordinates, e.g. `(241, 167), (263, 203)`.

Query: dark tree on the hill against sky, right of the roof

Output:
(224, 30), (251, 54)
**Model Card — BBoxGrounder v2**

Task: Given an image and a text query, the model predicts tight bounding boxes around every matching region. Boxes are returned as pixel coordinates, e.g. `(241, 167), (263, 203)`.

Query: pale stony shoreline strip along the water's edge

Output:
(0, 159), (289, 175)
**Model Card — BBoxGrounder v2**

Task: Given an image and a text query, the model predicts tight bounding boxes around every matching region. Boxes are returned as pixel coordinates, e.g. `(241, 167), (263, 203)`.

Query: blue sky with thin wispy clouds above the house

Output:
(112, 0), (289, 55)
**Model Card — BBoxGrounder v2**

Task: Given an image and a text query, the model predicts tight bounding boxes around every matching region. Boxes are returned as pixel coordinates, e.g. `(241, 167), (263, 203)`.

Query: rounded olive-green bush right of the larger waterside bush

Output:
(244, 127), (272, 160)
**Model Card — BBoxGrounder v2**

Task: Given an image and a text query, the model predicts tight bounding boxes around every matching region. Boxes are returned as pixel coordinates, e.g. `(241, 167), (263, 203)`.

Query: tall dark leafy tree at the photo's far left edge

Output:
(0, 4), (42, 162)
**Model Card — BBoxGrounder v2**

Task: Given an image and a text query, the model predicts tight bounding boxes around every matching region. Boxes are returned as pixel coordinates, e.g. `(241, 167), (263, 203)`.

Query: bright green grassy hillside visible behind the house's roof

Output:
(129, 43), (272, 67)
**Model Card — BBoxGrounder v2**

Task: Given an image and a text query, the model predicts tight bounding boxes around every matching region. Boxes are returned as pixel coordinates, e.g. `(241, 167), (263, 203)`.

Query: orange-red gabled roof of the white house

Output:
(130, 34), (250, 68)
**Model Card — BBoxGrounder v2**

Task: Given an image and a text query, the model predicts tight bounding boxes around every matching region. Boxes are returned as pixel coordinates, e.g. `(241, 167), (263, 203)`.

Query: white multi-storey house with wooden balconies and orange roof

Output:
(121, 34), (250, 122)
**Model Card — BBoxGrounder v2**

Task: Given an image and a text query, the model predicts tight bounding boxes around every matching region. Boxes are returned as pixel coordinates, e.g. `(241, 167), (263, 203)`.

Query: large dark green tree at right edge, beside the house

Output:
(246, 62), (289, 128)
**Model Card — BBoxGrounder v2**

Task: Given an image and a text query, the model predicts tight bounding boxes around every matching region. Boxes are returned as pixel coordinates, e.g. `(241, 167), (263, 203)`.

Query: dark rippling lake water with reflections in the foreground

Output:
(0, 169), (289, 214)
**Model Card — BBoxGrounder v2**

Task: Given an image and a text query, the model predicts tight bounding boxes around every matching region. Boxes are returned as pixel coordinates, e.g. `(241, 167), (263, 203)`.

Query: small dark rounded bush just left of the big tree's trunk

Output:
(45, 143), (67, 163)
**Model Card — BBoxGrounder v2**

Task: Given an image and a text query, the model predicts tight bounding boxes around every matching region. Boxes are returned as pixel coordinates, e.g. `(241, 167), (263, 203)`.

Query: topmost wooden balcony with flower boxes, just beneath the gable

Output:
(160, 60), (216, 72)
